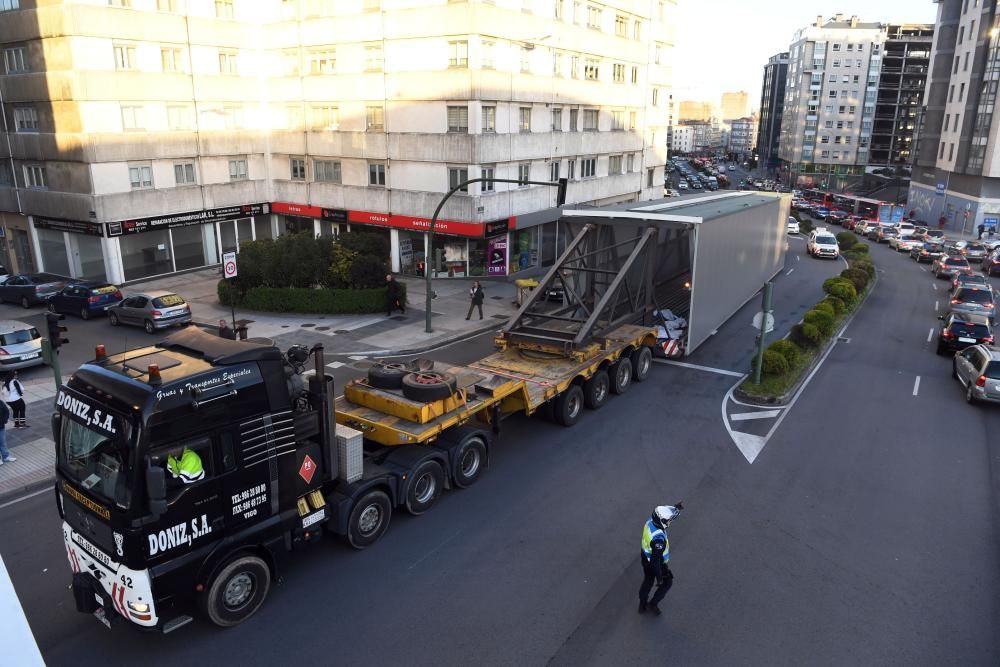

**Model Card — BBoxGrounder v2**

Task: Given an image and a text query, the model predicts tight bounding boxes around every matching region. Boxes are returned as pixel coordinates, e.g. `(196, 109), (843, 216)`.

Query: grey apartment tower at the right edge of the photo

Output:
(907, 0), (1000, 233)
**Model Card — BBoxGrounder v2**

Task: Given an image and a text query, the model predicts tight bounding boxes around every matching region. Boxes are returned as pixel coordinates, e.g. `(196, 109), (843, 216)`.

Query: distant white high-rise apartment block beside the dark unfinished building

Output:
(778, 14), (886, 187)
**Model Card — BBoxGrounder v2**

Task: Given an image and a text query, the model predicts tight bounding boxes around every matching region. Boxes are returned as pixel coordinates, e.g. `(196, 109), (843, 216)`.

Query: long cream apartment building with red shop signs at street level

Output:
(0, 0), (676, 282)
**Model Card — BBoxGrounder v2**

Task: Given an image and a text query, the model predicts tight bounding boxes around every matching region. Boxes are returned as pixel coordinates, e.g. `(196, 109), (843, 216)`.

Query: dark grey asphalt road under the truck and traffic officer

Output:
(0, 232), (1000, 665)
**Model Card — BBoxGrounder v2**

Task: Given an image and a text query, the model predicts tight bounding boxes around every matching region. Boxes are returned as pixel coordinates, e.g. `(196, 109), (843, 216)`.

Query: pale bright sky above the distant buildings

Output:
(673, 0), (937, 109)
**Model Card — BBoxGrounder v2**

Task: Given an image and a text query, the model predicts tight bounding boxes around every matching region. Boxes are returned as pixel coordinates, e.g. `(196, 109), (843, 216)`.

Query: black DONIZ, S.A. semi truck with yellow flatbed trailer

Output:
(52, 224), (657, 633)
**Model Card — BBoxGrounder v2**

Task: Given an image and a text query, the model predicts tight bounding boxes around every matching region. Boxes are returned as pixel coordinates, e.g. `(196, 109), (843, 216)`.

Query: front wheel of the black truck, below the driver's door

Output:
(201, 556), (271, 628)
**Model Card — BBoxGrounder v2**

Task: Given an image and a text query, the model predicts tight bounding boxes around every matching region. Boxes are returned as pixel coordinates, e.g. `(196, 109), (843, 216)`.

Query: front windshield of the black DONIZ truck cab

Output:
(58, 412), (132, 508)
